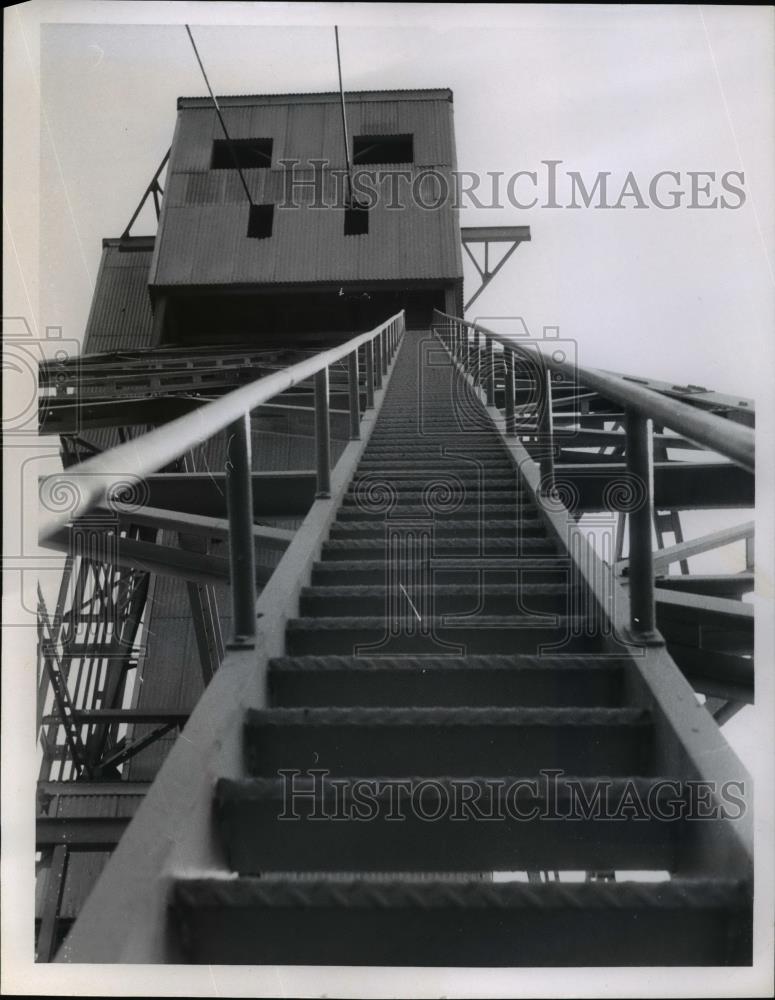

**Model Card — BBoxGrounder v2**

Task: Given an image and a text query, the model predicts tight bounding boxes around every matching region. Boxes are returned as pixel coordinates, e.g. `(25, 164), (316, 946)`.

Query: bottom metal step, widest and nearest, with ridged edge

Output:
(172, 878), (751, 967)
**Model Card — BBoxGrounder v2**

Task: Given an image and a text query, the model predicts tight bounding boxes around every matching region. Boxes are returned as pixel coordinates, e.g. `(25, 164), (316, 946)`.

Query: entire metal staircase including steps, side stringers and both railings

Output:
(44, 315), (752, 967)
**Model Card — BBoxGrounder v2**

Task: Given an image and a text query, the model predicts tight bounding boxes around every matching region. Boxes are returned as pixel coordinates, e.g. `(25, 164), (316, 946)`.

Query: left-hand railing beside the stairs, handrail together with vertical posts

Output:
(40, 312), (404, 645)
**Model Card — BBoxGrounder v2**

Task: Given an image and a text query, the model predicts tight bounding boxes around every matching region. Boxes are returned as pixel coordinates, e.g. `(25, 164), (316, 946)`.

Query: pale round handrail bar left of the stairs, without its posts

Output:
(39, 310), (404, 541)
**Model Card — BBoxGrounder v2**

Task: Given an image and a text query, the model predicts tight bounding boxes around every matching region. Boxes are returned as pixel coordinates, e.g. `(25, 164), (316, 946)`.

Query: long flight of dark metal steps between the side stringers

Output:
(164, 334), (750, 966)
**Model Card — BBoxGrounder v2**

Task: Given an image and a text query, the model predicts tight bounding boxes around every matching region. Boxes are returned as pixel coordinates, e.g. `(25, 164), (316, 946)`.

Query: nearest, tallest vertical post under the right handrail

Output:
(625, 410), (659, 642)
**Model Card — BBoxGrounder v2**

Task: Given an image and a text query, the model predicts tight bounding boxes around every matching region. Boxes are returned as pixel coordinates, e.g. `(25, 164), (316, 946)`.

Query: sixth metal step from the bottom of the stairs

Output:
(299, 581), (578, 620)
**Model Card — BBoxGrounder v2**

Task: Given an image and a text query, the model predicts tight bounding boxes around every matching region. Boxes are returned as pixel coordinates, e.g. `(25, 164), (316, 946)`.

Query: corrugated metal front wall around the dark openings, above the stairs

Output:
(151, 91), (462, 286)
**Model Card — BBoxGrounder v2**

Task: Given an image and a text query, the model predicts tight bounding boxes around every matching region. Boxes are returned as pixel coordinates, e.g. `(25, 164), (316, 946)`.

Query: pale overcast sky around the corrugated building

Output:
(16, 3), (775, 395)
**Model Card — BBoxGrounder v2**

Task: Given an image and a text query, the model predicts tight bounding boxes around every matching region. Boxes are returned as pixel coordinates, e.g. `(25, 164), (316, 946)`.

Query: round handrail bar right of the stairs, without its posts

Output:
(435, 309), (755, 472)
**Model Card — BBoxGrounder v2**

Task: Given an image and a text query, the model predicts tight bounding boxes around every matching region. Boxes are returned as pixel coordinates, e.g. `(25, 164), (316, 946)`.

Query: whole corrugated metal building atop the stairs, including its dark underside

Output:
(149, 90), (463, 343)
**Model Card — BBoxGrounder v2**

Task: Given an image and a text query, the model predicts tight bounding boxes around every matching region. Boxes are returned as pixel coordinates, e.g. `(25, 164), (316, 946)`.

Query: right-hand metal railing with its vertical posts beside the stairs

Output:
(434, 310), (754, 644)
